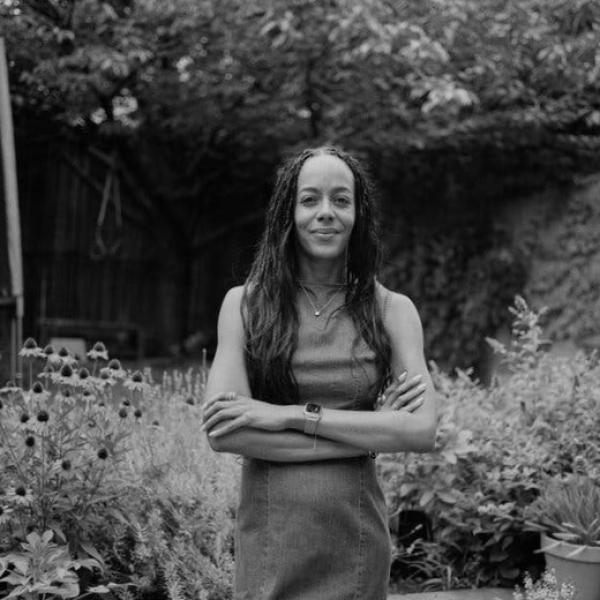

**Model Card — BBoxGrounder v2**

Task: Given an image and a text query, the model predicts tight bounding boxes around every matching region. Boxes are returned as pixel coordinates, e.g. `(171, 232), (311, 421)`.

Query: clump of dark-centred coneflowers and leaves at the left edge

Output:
(0, 338), (146, 594)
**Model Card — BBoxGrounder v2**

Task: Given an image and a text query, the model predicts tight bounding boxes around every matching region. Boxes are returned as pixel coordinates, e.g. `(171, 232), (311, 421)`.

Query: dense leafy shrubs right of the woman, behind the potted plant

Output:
(380, 298), (600, 586)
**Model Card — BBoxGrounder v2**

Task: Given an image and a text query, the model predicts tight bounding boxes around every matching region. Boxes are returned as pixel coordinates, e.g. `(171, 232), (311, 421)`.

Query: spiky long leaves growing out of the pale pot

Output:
(525, 474), (600, 546)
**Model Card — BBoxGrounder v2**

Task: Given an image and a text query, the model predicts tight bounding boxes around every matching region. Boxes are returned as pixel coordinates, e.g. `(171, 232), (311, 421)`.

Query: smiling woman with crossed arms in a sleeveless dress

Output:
(203, 147), (436, 600)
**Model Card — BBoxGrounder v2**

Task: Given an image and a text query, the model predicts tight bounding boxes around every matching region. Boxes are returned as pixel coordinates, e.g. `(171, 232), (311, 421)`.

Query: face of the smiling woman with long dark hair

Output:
(294, 154), (356, 259)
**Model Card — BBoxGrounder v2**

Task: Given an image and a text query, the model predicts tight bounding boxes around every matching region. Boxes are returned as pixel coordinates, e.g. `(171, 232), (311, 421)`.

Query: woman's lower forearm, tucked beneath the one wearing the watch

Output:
(208, 427), (368, 462)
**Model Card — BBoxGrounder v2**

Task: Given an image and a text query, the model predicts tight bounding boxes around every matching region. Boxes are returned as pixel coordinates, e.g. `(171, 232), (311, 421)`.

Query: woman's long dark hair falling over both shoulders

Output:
(242, 146), (391, 404)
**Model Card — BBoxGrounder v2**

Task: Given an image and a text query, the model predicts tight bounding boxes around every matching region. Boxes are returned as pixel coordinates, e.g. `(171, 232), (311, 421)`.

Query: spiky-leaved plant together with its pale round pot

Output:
(525, 474), (600, 600)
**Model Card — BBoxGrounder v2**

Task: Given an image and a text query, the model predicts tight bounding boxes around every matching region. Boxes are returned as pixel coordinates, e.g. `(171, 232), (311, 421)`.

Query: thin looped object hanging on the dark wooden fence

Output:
(90, 152), (123, 260)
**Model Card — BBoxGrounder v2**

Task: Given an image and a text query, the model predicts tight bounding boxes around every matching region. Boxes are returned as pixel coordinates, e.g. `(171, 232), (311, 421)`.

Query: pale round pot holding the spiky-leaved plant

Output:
(540, 533), (600, 600)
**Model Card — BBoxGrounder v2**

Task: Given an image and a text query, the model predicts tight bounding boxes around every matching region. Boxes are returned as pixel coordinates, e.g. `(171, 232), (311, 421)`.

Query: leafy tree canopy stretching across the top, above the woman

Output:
(0, 0), (600, 144)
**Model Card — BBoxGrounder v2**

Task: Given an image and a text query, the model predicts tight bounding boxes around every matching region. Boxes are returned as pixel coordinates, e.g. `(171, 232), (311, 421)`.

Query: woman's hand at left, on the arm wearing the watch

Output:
(202, 392), (289, 437)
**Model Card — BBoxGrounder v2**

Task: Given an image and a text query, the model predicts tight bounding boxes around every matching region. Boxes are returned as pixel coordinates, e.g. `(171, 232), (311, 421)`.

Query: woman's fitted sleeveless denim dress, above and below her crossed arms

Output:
(234, 288), (392, 600)
